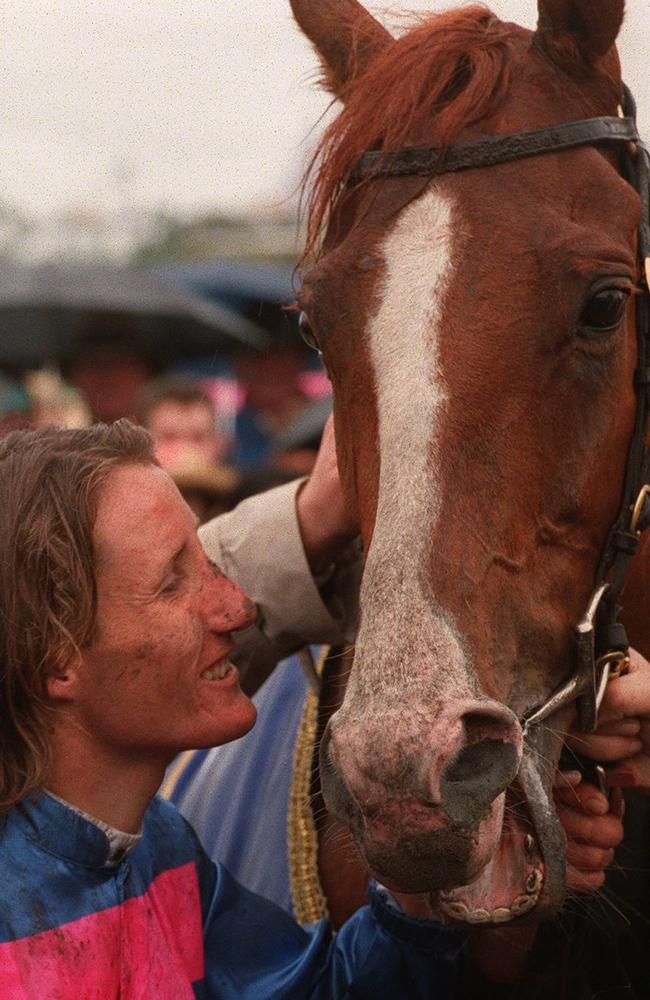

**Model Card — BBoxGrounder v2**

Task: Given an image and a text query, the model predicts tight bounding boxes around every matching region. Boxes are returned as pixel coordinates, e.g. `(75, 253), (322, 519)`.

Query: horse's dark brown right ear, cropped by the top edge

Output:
(535, 0), (625, 64)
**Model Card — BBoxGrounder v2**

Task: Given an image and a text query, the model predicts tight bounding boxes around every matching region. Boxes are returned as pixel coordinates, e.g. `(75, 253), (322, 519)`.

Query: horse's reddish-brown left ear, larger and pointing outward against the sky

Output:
(291, 0), (393, 97)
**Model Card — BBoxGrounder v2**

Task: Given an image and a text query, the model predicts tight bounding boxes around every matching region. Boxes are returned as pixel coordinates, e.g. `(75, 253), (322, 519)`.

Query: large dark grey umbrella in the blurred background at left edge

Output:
(0, 262), (269, 370)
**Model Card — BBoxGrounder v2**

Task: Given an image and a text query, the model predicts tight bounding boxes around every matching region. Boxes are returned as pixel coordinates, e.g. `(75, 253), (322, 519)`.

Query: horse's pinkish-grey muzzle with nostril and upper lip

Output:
(321, 699), (522, 891)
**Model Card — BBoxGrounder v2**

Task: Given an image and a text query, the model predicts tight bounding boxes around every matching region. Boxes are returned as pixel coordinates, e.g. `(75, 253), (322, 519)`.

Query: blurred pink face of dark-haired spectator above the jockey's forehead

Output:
(147, 399), (227, 465)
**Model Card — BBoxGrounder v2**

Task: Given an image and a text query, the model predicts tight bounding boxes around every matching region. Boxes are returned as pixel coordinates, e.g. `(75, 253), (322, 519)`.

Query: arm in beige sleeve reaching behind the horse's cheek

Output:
(199, 421), (361, 693)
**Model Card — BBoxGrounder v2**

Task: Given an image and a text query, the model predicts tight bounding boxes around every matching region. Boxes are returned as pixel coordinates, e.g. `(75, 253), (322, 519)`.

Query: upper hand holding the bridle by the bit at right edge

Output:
(567, 650), (650, 793)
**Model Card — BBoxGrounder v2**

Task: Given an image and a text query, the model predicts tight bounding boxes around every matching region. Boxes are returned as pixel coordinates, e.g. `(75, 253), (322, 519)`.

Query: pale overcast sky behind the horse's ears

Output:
(0, 0), (650, 220)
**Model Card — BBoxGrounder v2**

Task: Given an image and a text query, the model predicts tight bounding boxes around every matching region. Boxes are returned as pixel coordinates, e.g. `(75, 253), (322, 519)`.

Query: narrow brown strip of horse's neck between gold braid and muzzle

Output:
(312, 650), (369, 927)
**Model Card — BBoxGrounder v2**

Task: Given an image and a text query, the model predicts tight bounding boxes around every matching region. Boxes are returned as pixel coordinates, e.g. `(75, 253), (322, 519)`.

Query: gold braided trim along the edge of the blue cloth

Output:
(287, 647), (330, 924)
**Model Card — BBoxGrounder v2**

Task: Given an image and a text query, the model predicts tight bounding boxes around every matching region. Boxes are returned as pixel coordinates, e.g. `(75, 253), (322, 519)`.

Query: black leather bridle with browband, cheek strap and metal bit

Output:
(347, 87), (650, 735)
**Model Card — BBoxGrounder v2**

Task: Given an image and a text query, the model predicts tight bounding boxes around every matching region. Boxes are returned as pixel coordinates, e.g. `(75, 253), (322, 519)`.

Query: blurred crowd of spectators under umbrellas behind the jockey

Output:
(0, 294), (331, 522)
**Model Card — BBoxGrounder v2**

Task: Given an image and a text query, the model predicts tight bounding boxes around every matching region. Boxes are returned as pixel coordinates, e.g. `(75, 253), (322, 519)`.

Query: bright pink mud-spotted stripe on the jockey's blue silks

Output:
(0, 863), (204, 1000)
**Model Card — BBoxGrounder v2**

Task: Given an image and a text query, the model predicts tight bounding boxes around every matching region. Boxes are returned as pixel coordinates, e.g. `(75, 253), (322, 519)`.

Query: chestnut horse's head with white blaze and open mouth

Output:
(291, 0), (650, 924)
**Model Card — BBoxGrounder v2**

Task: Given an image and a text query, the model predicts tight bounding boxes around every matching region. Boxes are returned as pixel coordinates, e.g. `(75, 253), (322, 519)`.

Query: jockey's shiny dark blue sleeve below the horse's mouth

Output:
(204, 866), (465, 1000)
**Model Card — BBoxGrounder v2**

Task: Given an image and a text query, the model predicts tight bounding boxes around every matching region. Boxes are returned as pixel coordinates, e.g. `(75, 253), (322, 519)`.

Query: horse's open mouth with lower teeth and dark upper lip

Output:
(334, 752), (565, 925)
